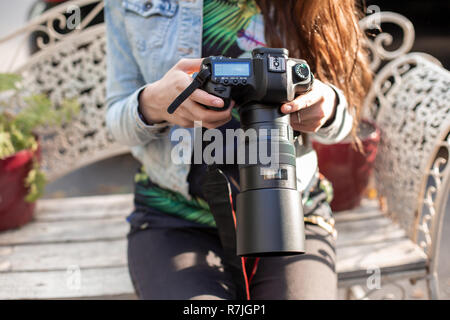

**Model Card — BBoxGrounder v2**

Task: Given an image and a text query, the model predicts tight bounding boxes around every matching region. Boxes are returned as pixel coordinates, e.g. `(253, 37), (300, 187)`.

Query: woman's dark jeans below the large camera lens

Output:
(128, 214), (337, 300)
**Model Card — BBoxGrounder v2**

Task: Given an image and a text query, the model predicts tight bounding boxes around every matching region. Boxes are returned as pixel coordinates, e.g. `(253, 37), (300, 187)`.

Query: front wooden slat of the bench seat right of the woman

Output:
(336, 239), (427, 279)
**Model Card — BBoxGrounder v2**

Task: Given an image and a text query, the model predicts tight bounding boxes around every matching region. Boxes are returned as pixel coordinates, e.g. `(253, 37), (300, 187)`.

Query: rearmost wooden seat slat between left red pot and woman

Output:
(35, 194), (133, 221)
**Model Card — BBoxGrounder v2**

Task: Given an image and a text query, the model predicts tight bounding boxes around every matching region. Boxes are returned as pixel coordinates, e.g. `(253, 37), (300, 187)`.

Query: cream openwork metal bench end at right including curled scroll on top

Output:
(360, 12), (450, 252)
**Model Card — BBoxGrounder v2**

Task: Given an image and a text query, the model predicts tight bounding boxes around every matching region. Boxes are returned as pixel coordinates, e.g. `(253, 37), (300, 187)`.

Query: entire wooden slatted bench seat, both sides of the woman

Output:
(0, 194), (427, 299)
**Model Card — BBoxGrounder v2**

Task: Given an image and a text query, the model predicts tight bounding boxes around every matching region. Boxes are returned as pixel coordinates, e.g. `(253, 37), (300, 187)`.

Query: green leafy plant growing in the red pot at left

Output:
(0, 74), (80, 202)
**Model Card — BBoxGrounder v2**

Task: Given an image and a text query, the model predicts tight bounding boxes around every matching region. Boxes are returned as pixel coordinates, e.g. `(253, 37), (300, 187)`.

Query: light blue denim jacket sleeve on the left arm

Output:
(105, 0), (168, 147)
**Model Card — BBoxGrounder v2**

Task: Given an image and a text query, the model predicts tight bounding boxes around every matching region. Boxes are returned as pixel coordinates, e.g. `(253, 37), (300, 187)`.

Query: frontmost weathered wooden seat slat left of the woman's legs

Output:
(0, 267), (134, 299)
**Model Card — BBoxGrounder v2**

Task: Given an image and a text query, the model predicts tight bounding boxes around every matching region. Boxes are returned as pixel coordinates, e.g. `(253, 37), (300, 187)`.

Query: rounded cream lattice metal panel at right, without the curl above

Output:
(365, 54), (450, 241)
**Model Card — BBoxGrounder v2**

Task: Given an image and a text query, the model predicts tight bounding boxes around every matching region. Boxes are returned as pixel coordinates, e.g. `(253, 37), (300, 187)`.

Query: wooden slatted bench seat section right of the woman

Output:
(335, 200), (427, 287)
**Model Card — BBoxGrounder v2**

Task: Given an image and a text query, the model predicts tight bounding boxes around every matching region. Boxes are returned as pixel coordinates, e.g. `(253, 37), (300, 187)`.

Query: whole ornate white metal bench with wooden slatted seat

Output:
(0, 0), (450, 299)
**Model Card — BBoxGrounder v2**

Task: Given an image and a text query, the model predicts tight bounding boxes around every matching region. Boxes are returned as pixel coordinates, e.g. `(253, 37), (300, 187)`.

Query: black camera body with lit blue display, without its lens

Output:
(202, 48), (314, 110)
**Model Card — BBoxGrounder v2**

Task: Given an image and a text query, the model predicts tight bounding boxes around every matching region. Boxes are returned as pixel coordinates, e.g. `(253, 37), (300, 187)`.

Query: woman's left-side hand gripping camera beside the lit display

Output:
(139, 59), (233, 128)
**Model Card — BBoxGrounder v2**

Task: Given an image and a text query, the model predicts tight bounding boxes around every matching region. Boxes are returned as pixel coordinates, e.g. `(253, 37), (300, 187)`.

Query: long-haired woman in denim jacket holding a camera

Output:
(105, 0), (371, 299)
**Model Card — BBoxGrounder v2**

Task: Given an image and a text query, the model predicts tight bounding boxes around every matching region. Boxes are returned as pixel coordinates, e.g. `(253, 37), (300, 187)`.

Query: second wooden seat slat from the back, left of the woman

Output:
(0, 218), (129, 246)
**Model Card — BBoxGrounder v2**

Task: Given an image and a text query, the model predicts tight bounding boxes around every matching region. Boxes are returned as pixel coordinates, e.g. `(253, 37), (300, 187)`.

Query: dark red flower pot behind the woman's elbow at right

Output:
(313, 120), (380, 211)
